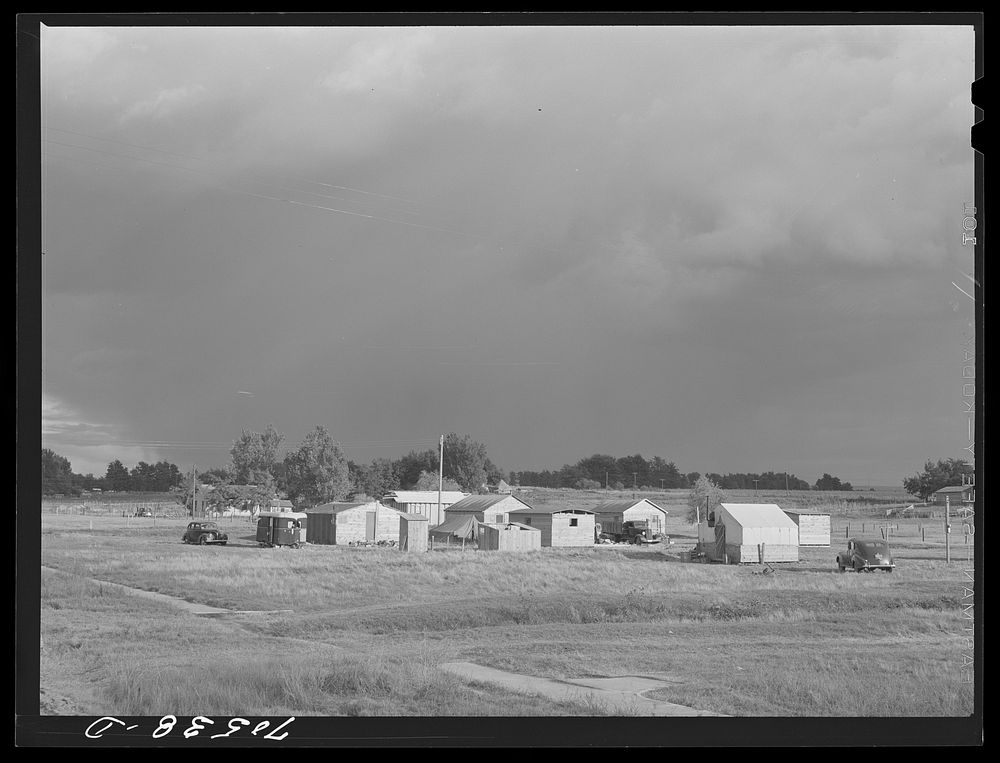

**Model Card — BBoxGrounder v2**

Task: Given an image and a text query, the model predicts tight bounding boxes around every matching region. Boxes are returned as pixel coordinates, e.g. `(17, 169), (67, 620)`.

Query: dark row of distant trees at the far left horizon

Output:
(42, 448), (183, 495)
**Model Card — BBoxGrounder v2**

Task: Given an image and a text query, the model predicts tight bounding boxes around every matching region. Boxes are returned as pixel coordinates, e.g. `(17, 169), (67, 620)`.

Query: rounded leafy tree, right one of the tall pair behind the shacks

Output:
(284, 426), (351, 506)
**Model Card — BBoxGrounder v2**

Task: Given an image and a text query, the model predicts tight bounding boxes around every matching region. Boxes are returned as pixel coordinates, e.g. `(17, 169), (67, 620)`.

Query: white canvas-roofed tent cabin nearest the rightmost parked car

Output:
(698, 503), (799, 564)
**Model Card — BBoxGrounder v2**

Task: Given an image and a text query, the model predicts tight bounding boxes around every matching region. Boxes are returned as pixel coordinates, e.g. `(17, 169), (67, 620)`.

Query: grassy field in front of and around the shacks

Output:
(41, 497), (972, 716)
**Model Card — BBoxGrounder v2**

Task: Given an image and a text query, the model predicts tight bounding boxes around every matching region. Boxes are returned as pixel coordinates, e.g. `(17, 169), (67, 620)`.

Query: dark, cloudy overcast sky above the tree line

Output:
(41, 26), (974, 486)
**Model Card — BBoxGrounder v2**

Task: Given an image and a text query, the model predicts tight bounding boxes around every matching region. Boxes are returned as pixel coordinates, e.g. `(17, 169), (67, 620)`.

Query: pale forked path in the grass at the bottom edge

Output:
(440, 662), (721, 716)
